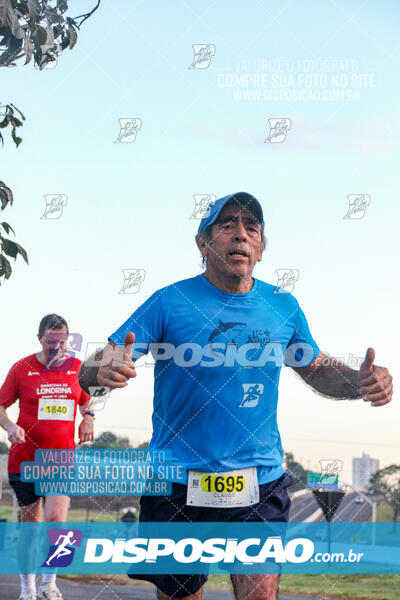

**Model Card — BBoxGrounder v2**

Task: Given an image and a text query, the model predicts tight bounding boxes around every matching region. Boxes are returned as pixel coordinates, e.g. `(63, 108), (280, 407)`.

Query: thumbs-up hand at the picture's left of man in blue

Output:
(97, 331), (136, 390)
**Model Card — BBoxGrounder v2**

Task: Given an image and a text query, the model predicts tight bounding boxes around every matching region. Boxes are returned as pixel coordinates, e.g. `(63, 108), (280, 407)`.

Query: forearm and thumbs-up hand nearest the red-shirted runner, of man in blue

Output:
(78, 331), (136, 395)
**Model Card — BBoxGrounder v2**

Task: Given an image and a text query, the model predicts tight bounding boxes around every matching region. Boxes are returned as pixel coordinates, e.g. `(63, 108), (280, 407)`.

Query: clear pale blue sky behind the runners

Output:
(0, 0), (400, 480)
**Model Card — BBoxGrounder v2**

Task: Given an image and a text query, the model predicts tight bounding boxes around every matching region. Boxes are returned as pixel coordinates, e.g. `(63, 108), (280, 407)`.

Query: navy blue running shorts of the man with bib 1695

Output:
(128, 473), (294, 598)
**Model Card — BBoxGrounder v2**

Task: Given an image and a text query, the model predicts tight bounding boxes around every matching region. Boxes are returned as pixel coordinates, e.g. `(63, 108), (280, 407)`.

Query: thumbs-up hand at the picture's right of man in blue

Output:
(358, 348), (393, 406)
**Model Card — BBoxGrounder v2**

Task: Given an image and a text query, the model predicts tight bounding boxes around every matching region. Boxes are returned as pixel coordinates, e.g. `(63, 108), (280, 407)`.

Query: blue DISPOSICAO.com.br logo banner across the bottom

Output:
(0, 522), (400, 574)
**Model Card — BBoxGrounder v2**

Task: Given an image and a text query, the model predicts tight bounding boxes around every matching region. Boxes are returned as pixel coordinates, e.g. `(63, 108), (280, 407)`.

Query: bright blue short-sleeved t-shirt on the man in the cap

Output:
(109, 275), (319, 483)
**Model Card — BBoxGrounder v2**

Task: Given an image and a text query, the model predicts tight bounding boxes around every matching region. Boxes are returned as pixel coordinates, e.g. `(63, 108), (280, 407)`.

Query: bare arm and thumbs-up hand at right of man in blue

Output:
(293, 348), (393, 406)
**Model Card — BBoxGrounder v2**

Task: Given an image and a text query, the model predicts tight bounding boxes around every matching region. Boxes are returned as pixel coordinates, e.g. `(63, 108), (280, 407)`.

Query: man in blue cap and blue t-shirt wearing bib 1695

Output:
(79, 192), (392, 600)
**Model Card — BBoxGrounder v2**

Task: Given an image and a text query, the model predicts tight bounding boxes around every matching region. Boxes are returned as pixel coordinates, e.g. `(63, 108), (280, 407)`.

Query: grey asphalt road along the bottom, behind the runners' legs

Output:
(0, 575), (338, 600)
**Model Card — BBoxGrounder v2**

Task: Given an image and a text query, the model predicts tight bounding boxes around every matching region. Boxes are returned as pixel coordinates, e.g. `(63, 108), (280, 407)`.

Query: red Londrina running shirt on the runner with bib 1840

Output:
(0, 354), (90, 473)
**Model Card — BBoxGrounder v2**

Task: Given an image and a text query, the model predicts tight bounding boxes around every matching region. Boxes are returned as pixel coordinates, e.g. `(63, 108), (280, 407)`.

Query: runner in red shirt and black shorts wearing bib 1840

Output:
(0, 314), (94, 600)
